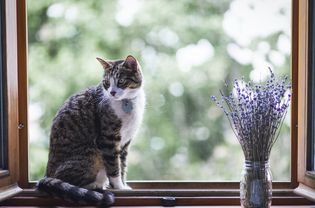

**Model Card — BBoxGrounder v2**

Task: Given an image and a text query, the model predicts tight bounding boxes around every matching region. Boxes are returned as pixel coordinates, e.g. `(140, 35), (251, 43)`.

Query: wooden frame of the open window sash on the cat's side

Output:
(0, 1), (22, 200)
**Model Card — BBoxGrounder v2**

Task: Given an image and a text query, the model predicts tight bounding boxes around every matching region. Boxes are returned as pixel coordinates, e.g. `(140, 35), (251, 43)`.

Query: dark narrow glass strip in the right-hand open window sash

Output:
(307, 1), (315, 171)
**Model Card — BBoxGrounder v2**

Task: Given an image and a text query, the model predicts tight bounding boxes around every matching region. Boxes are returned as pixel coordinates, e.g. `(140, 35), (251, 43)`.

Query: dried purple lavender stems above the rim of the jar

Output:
(211, 68), (291, 161)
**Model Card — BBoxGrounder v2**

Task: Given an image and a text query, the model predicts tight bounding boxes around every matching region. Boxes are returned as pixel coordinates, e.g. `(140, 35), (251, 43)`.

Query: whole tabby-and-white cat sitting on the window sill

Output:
(37, 55), (145, 206)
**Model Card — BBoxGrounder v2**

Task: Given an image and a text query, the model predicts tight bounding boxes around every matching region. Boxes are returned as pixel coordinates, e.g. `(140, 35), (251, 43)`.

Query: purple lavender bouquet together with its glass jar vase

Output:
(212, 69), (291, 208)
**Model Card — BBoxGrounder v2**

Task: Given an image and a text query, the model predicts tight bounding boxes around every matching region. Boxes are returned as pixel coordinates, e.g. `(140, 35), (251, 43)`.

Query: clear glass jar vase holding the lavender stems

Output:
(240, 160), (272, 208)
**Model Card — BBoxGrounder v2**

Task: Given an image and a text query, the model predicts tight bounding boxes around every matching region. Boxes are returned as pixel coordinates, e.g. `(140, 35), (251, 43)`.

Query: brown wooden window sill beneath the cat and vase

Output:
(0, 189), (314, 207)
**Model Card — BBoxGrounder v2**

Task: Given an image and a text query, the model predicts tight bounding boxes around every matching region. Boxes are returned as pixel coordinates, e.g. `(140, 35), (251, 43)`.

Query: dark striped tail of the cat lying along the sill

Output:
(36, 177), (114, 206)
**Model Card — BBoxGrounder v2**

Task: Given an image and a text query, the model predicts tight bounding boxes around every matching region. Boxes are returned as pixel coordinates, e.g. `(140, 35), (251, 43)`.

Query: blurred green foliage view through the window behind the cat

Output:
(28, 0), (291, 181)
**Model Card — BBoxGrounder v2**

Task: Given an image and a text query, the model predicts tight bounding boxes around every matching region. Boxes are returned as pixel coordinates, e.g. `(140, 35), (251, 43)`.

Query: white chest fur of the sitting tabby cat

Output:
(110, 90), (145, 146)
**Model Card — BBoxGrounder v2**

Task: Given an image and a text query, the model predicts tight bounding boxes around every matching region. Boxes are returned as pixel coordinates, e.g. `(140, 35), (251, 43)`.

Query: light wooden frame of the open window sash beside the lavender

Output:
(295, 0), (315, 201)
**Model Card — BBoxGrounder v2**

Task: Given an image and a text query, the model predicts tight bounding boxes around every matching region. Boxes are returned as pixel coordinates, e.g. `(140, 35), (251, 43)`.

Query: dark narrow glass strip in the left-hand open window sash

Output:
(0, 1), (7, 169)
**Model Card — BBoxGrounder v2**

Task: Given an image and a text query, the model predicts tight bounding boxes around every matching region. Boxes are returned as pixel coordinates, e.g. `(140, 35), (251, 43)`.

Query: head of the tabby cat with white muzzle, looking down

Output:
(96, 55), (143, 100)
